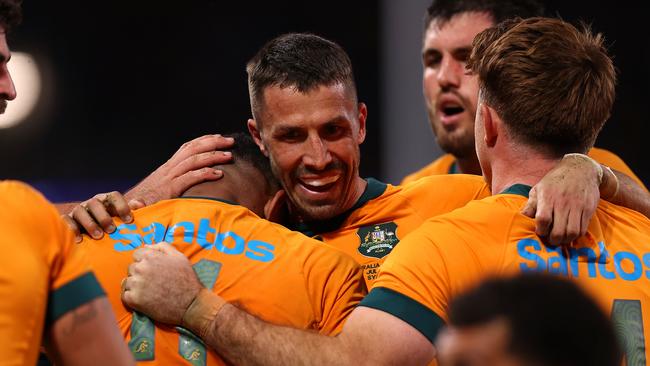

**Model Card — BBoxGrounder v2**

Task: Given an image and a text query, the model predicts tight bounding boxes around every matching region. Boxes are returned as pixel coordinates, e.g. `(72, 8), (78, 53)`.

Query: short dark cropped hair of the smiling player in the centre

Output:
(246, 33), (357, 119)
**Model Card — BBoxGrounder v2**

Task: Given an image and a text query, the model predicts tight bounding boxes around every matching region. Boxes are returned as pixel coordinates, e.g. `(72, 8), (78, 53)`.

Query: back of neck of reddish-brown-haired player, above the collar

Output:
(487, 148), (559, 194)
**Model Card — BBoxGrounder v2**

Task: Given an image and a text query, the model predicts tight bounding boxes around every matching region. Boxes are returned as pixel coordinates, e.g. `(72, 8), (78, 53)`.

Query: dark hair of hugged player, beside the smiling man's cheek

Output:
(225, 132), (280, 195)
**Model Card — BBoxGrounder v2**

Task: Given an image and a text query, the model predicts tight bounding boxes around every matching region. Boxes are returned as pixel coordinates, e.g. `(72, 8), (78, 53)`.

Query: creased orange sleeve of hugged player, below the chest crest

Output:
(303, 239), (368, 335)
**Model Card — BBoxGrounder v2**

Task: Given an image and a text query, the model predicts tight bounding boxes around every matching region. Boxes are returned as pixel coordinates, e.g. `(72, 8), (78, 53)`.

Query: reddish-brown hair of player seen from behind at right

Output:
(467, 17), (616, 157)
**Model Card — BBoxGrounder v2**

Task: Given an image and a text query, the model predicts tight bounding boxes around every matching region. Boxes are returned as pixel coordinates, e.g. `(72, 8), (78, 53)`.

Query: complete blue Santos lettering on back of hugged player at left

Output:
(109, 219), (275, 262)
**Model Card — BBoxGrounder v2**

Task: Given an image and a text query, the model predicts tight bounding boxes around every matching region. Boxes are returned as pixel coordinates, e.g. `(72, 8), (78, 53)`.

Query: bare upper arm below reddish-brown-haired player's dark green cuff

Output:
(338, 306), (435, 365)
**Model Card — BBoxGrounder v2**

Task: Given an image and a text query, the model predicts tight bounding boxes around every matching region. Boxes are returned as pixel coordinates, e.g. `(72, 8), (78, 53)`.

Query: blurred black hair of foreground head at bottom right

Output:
(448, 274), (621, 366)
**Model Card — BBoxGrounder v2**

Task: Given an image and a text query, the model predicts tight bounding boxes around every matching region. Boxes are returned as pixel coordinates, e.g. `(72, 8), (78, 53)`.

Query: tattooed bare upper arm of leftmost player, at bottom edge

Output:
(46, 297), (134, 366)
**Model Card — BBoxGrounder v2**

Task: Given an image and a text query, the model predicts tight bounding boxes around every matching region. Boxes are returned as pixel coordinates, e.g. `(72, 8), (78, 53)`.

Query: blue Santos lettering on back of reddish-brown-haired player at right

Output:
(517, 239), (650, 281)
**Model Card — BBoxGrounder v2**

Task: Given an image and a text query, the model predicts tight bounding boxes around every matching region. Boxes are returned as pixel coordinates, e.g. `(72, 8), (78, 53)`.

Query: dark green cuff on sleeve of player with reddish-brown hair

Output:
(359, 287), (445, 343)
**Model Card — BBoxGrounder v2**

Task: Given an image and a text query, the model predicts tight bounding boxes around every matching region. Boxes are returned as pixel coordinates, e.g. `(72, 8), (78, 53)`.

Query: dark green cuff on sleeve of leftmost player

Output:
(45, 272), (105, 326)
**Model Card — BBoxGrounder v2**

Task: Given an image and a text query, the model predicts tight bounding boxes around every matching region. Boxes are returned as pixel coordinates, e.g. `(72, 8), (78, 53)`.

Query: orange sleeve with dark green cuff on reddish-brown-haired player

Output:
(361, 209), (503, 343)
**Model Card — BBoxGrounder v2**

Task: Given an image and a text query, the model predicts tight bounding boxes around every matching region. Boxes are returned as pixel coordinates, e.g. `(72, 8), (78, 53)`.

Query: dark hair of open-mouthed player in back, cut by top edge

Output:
(424, 0), (545, 32)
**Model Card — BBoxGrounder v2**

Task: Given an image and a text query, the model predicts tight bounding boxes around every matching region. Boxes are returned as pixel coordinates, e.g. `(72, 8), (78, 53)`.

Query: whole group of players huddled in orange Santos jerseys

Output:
(0, 0), (650, 365)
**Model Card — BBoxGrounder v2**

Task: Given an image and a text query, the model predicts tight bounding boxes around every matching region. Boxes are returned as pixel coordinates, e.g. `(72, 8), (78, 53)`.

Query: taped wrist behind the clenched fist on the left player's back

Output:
(181, 288), (226, 339)
